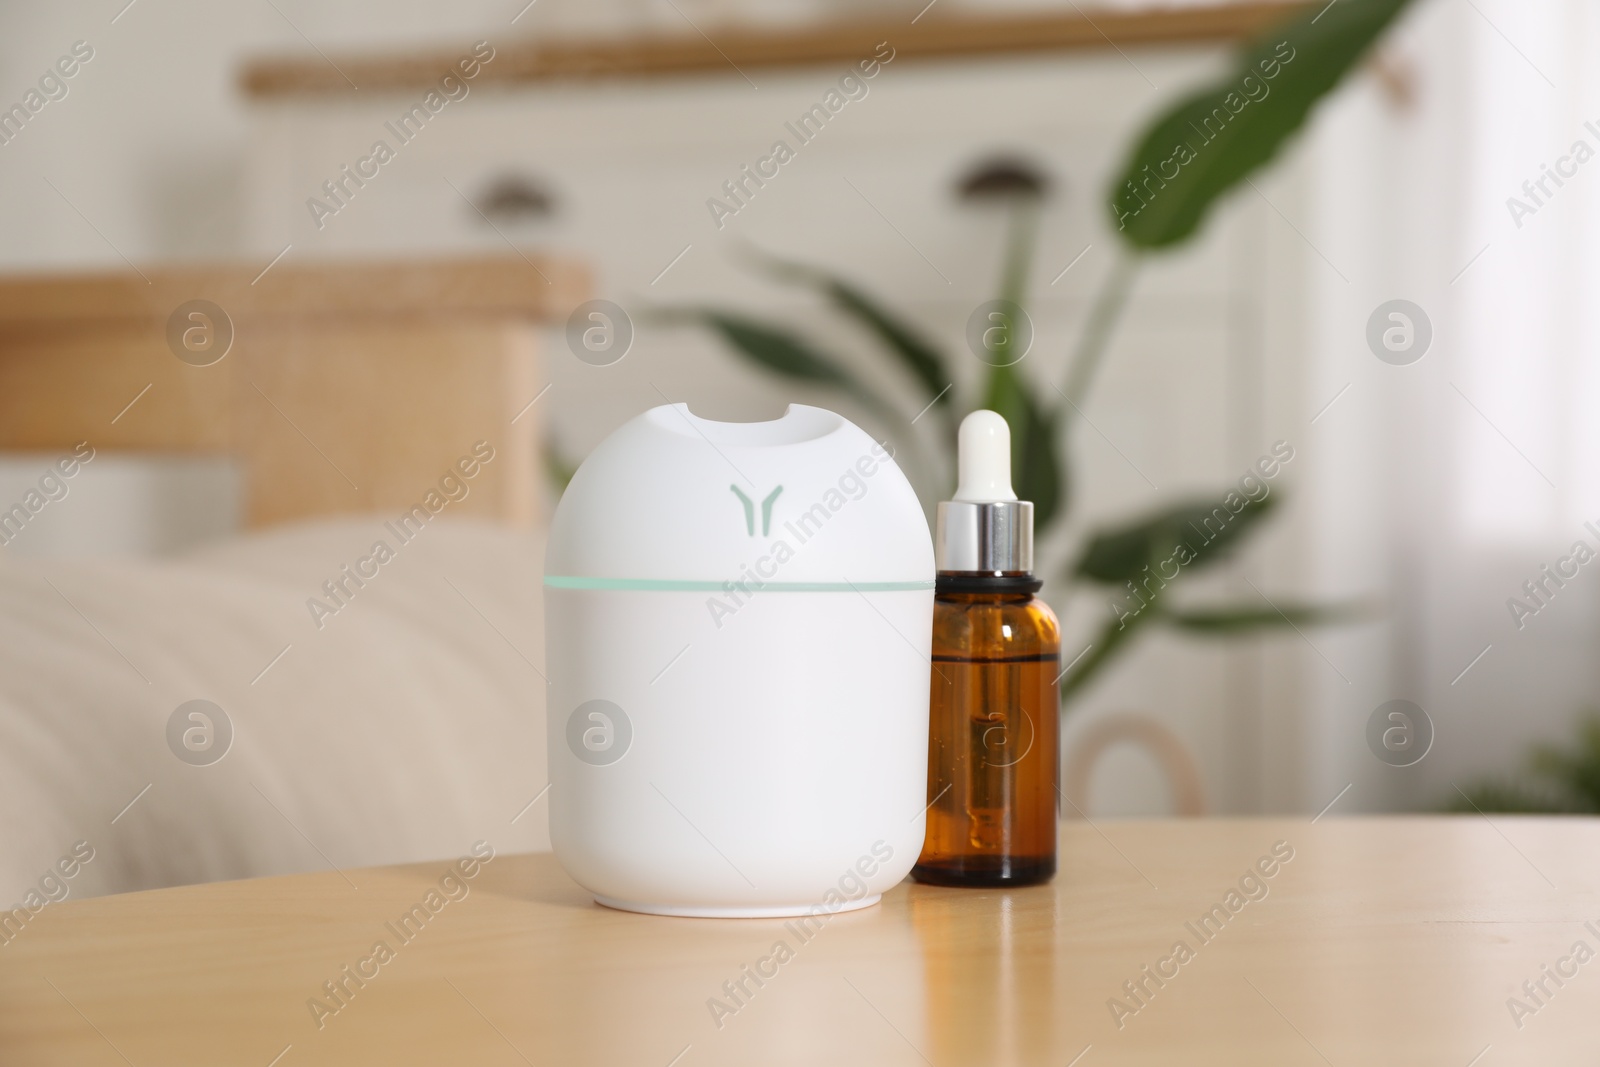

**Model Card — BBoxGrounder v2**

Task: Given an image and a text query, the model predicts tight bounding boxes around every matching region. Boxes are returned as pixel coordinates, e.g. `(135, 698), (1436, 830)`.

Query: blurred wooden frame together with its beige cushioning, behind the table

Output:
(0, 258), (587, 902)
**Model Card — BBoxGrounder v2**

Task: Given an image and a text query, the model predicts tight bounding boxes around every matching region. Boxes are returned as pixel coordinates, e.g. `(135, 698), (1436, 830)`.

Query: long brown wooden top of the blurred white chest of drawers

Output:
(242, 0), (1302, 99)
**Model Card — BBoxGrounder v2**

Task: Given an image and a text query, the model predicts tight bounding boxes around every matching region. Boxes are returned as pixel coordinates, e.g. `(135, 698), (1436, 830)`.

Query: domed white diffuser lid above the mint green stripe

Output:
(544, 403), (934, 592)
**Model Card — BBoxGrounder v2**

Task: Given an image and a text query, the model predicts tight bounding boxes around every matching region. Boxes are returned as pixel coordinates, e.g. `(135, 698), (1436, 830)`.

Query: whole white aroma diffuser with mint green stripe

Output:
(544, 405), (934, 917)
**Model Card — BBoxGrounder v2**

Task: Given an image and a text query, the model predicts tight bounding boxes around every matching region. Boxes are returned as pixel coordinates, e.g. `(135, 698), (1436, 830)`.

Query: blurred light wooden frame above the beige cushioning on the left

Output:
(0, 258), (589, 526)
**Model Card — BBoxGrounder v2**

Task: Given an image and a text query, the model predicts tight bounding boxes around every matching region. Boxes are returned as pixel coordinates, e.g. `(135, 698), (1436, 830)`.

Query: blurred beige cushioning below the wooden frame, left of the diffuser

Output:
(0, 518), (549, 909)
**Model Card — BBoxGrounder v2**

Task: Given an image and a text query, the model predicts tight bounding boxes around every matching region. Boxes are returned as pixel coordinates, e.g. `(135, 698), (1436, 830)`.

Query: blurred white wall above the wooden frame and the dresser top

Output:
(0, 0), (1273, 269)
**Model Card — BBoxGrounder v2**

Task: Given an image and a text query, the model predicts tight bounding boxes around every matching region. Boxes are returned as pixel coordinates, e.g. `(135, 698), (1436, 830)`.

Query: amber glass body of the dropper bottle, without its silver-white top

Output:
(912, 574), (1061, 886)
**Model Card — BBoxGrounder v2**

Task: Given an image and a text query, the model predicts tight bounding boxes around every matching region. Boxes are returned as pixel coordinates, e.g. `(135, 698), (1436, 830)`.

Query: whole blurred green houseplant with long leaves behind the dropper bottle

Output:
(662, 0), (1410, 704)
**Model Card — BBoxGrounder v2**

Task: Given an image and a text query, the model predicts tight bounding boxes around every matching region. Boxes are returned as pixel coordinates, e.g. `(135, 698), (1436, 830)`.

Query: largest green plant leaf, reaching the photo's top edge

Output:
(1110, 0), (1410, 248)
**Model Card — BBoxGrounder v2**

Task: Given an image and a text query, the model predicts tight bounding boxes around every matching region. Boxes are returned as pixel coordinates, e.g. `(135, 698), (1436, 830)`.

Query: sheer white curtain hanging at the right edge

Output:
(1298, 0), (1600, 811)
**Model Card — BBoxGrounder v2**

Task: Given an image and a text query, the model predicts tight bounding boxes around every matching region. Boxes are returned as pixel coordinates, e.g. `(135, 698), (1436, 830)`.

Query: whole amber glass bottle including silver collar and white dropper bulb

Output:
(912, 411), (1061, 886)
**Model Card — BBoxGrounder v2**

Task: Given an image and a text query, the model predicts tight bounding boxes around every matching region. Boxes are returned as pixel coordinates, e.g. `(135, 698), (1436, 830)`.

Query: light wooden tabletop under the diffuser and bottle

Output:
(0, 817), (1600, 1067)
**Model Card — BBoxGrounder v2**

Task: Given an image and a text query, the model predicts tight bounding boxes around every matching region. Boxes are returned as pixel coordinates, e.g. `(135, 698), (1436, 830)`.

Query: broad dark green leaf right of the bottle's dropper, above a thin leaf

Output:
(1072, 491), (1278, 585)
